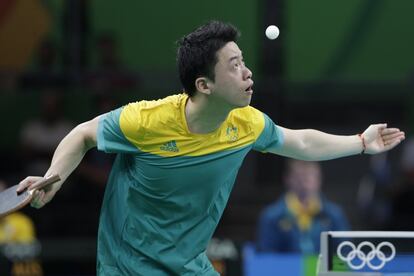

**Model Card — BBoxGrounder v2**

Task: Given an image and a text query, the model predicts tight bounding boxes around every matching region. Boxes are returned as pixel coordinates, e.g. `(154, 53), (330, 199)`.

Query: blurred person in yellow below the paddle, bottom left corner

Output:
(0, 180), (43, 276)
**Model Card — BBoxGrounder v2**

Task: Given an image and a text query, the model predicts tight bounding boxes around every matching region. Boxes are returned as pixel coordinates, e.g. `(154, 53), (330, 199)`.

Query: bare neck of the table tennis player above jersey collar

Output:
(185, 93), (233, 134)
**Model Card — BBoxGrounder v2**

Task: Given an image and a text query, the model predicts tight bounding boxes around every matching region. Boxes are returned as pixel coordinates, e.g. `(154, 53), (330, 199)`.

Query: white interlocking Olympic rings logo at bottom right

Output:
(336, 241), (395, 270)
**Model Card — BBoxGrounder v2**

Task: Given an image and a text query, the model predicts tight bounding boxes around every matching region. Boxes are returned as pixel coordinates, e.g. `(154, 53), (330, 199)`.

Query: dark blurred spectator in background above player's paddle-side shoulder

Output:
(86, 34), (137, 94)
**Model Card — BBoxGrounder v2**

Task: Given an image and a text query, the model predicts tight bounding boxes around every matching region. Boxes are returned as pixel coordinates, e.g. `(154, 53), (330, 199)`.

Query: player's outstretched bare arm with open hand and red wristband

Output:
(270, 124), (405, 161)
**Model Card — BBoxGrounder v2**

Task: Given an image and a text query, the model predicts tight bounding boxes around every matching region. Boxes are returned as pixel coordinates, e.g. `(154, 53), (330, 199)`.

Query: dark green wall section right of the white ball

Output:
(281, 0), (414, 81)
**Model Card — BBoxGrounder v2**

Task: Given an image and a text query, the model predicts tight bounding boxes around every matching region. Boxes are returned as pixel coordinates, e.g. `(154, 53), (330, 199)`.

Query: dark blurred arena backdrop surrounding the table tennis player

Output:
(0, 0), (414, 275)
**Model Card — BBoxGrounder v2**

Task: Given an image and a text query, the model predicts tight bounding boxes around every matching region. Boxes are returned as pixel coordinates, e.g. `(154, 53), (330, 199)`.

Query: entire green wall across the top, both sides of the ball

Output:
(39, 0), (414, 81)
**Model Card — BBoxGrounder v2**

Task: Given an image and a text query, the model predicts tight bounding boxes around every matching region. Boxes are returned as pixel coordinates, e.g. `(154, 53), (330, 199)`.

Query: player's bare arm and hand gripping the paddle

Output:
(18, 117), (99, 208)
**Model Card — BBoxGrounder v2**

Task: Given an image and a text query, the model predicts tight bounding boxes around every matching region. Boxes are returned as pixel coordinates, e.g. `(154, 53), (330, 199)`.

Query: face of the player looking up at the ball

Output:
(210, 42), (253, 108)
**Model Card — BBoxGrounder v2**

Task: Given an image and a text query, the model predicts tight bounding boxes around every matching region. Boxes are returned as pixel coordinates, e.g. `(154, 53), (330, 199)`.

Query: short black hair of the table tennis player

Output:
(177, 21), (240, 97)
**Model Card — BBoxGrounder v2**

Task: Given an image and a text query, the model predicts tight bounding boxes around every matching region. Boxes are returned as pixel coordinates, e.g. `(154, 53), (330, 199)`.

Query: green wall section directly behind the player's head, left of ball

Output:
(90, 0), (258, 71)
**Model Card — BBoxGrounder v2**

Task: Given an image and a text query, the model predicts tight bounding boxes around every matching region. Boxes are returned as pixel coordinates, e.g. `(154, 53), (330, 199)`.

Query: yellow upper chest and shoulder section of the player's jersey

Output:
(120, 94), (265, 156)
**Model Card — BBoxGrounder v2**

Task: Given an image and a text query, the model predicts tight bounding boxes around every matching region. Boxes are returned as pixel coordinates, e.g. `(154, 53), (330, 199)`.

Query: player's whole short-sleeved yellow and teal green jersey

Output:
(97, 94), (283, 276)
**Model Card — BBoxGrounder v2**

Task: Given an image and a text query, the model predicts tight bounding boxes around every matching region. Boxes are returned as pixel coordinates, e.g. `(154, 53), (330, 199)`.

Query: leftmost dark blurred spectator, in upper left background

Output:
(20, 40), (68, 89)
